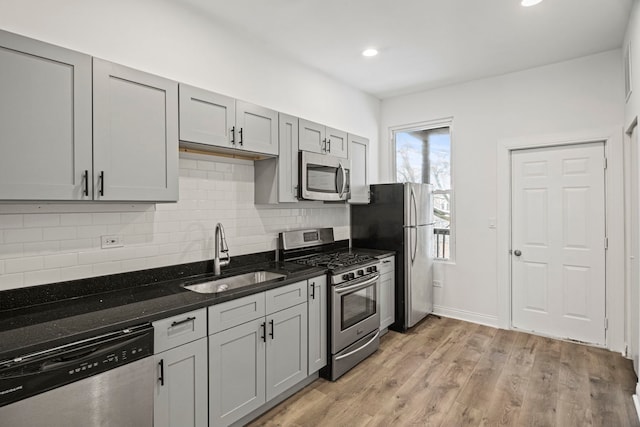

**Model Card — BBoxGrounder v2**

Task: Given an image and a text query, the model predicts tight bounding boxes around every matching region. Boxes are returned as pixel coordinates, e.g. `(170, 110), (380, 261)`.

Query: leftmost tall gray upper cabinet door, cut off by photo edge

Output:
(0, 31), (92, 200)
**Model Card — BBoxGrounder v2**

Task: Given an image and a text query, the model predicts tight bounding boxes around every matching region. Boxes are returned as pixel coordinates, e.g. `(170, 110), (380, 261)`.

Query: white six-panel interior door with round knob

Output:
(511, 143), (606, 345)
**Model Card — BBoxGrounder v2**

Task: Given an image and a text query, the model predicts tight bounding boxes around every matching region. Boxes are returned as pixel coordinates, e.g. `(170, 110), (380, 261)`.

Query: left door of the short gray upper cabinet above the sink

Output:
(180, 84), (236, 148)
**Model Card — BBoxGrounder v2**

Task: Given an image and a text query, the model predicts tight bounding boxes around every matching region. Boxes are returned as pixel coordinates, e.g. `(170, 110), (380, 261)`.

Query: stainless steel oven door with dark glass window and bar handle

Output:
(331, 274), (380, 354)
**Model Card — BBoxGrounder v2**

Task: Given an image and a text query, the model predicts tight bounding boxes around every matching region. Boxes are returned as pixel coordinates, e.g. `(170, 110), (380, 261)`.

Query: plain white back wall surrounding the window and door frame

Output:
(380, 50), (624, 325)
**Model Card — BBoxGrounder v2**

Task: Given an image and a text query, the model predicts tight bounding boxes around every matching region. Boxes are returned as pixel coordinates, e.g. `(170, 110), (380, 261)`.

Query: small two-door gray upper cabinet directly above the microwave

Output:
(299, 119), (349, 159)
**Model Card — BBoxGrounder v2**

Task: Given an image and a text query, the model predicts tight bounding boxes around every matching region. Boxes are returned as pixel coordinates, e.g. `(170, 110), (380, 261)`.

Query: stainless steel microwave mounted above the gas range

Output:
(299, 151), (350, 201)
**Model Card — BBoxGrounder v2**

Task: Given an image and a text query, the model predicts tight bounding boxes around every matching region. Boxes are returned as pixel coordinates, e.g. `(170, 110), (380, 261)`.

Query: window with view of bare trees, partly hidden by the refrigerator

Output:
(393, 121), (453, 260)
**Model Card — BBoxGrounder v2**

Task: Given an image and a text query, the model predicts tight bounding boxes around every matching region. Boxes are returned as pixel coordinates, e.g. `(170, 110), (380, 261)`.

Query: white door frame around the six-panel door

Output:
(496, 127), (625, 353)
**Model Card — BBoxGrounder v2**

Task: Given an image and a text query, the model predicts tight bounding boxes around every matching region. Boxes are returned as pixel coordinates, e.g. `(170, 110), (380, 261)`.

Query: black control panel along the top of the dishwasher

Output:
(0, 324), (153, 407)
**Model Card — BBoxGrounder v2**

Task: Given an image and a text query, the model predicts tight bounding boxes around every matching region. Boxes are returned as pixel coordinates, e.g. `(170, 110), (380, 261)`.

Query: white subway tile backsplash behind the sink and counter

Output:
(0, 154), (350, 289)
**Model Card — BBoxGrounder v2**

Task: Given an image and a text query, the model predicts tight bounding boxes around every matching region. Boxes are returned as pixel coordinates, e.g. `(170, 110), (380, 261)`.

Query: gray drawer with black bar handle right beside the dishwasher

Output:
(153, 308), (207, 353)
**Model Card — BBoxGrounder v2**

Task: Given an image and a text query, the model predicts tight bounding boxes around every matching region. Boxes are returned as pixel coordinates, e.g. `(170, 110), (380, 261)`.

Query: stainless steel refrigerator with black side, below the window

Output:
(351, 183), (433, 331)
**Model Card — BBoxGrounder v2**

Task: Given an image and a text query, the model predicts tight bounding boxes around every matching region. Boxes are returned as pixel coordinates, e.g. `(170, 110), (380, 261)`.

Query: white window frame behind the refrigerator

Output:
(389, 117), (457, 264)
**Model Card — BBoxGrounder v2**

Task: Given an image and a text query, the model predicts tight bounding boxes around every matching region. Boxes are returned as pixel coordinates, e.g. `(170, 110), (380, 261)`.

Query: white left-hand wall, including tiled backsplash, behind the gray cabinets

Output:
(0, 0), (380, 289)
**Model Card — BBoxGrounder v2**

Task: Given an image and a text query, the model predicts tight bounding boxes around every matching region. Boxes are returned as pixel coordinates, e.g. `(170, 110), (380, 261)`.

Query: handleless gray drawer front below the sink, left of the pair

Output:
(209, 292), (265, 335)
